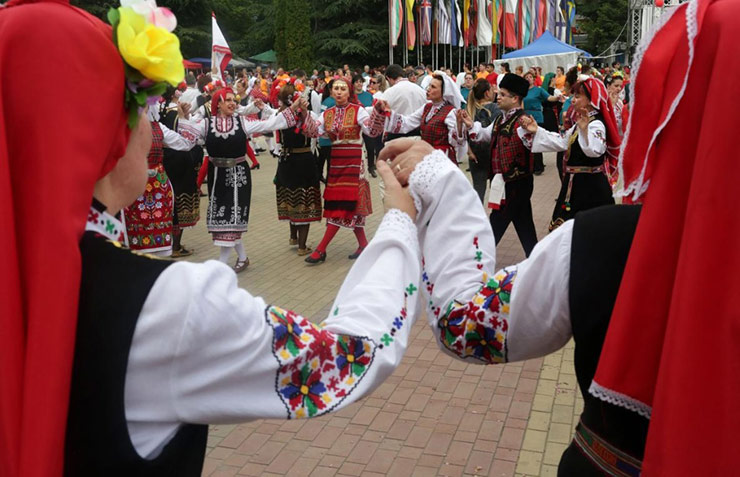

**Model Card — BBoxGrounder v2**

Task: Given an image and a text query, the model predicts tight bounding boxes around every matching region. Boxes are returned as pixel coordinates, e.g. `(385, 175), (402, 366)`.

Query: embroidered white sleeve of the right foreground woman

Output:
(409, 151), (572, 364)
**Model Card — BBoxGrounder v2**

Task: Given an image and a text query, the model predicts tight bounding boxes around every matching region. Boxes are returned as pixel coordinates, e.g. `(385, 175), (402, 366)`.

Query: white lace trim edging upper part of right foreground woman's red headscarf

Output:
(614, 1), (699, 201)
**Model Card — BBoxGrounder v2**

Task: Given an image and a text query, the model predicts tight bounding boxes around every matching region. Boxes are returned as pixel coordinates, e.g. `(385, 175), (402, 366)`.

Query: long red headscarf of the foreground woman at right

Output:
(591, 0), (740, 470)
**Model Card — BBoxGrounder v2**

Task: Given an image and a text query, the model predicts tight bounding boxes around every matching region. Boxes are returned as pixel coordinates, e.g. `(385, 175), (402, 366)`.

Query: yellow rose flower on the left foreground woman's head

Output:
(116, 7), (185, 86)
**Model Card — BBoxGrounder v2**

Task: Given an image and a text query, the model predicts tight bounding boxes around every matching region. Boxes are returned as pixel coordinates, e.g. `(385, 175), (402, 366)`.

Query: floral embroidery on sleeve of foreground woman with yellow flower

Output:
(265, 307), (382, 419)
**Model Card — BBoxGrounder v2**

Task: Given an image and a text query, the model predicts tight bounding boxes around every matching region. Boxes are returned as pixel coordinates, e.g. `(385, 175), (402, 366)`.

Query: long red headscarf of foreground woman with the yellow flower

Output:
(0, 1), (129, 477)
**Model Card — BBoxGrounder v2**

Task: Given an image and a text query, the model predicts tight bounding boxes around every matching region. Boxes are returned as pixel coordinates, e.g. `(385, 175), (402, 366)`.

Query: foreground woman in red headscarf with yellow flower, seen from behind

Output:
(0, 0), (492, 477)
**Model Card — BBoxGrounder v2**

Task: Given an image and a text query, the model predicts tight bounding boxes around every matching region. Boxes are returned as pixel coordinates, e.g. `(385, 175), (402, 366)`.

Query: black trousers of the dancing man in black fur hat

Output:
(491, 175), (537, 257)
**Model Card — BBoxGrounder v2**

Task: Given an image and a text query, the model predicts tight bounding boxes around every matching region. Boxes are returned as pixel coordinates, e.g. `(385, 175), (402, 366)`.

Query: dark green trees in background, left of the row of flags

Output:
(72, 0), (390, 69)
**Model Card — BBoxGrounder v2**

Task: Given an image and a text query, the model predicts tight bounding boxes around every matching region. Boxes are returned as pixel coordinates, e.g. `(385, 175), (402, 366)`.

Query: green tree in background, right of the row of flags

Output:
(576, 0), (629, 55)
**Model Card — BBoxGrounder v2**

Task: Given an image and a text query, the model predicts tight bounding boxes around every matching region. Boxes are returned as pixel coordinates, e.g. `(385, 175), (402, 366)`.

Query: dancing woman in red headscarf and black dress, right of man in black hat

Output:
(519, 78), (621, 231)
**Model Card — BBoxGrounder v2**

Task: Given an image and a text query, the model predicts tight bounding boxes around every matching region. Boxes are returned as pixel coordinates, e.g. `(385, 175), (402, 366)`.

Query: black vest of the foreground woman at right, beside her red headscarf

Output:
(569, 205), (649, 460)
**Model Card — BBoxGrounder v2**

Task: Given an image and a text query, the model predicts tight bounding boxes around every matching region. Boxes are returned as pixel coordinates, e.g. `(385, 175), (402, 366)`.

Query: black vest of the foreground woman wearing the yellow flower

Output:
(64, 232), (208, 477)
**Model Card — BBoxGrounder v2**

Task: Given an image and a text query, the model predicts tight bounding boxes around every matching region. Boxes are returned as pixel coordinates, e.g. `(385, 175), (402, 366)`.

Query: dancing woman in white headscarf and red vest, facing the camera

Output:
(379, 71), (465, 164)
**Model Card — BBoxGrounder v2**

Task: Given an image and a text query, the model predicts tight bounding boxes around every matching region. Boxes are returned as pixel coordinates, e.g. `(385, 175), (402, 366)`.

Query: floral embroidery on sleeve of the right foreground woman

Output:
(438, 267), (517, 363)
